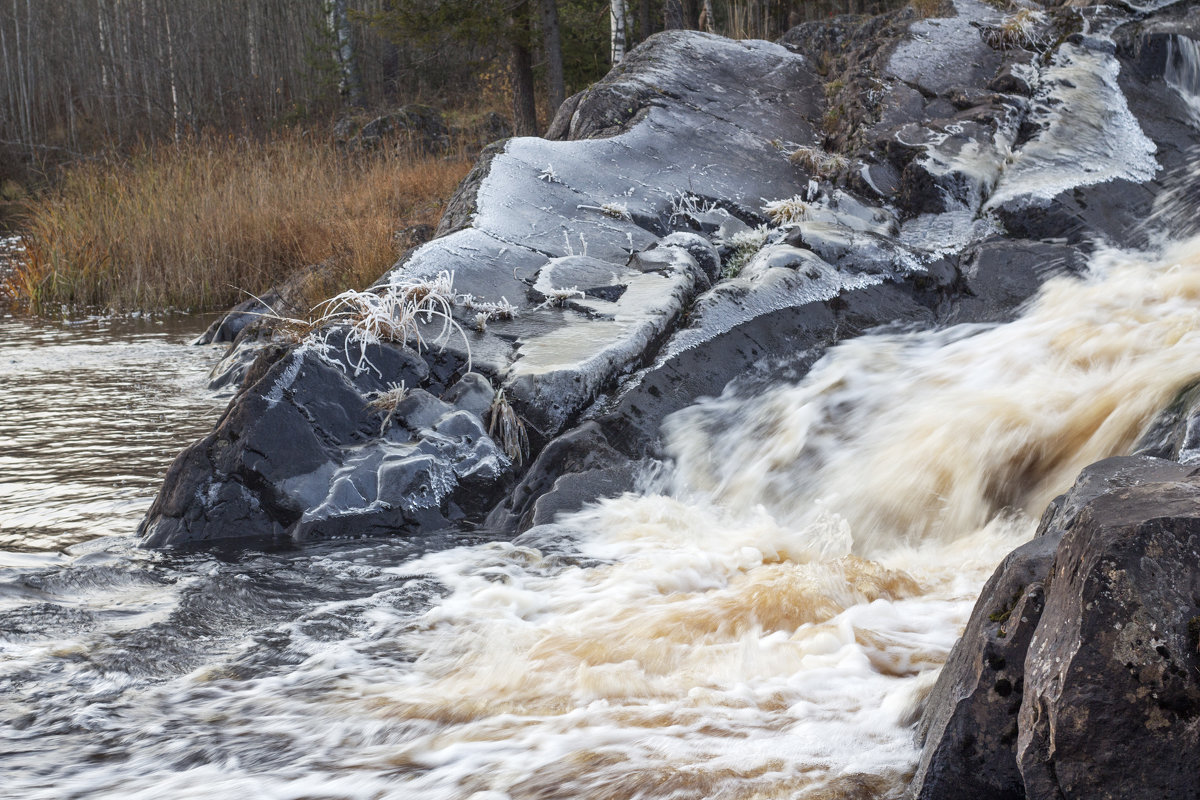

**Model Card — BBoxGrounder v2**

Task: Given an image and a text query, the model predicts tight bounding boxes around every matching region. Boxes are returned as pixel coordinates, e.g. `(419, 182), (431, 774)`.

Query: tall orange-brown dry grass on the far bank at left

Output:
(8, 132), (470, 314)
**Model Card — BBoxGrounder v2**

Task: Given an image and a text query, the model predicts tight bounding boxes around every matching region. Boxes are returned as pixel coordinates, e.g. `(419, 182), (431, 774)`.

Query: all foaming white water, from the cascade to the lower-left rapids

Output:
(11, 239), (1200, 800)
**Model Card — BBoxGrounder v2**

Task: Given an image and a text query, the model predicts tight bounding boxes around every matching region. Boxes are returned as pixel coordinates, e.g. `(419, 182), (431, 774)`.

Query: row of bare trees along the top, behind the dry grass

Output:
(0, 0), (902, 165)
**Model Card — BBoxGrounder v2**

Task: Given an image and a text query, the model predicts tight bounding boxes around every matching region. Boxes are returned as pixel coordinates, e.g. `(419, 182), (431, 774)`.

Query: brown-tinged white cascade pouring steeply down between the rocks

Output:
(670, 240), (1200, 553)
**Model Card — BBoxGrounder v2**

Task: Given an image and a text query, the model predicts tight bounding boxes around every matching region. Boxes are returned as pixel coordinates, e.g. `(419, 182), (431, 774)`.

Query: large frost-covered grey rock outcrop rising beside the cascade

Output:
(143, 0), (1195, 546)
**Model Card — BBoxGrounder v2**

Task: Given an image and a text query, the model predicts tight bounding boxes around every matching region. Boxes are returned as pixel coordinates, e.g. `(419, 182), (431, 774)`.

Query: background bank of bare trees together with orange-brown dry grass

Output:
(0, 0), (894, 313)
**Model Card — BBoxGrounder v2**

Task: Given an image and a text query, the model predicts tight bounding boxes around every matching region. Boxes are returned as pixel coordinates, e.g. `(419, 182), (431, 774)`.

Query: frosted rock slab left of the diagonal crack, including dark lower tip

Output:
(142, 32), (823, 546)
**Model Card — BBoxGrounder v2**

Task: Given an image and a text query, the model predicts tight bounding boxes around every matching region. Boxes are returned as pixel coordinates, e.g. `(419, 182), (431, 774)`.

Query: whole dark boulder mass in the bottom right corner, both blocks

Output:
(910, 456), (1200, 800)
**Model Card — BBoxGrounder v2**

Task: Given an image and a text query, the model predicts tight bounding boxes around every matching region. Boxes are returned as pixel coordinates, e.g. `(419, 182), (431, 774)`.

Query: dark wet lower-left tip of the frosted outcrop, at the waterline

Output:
(140, 335), (511, 547)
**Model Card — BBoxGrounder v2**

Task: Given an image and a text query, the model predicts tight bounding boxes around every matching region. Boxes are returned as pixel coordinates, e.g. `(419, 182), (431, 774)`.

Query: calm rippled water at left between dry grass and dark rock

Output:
(0, 317), (228, 551)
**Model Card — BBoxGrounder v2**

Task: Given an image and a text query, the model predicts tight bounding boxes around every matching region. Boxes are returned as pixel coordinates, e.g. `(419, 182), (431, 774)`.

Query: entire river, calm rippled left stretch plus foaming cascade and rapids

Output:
(0, 221), (1200, 800)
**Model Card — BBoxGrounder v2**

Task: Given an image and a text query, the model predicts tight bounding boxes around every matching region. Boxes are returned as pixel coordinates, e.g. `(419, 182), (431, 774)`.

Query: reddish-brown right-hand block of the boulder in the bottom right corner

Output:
(1018, 468), (1200, 799)
